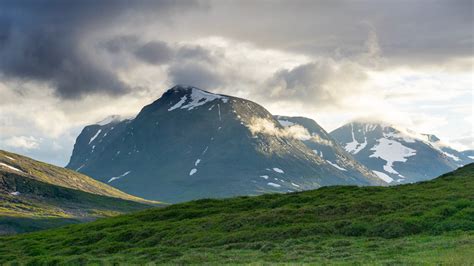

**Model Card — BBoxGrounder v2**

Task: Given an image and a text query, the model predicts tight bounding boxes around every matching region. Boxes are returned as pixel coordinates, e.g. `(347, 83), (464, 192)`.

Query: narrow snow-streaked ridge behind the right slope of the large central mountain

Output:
(275, 115), (380, 183)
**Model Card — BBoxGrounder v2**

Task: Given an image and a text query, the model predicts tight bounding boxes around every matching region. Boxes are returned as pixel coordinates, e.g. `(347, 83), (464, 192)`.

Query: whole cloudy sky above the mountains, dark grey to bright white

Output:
(0, 0), (474, 166)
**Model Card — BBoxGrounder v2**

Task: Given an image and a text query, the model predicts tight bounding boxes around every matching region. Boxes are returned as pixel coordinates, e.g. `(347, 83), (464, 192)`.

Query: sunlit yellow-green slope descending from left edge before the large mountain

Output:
(0, 150), (158, 235)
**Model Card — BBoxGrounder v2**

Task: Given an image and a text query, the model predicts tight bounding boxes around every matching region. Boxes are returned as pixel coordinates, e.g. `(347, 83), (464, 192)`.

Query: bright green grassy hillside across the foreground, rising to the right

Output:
(0, 164), (474, 264)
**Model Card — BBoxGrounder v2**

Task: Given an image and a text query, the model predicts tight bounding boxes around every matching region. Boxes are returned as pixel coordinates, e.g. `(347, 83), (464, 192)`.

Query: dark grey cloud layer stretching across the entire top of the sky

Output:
(0, 0), (473, 99)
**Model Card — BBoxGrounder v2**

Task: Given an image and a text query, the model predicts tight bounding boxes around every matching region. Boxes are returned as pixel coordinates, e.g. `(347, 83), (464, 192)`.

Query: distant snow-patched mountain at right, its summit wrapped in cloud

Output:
(331, 122), (464, 184)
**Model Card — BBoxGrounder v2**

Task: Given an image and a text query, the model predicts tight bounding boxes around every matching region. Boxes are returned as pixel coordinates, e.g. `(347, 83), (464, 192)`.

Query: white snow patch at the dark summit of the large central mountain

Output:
(168, 86), (229, 111)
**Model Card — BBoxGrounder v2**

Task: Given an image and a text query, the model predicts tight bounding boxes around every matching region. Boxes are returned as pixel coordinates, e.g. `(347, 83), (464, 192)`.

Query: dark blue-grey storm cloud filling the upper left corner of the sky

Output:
(0, 0), (202, 98)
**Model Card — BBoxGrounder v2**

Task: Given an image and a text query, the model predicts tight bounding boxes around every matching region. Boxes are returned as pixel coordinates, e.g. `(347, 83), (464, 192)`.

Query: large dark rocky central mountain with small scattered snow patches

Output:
(67, 86), (383, 202)
